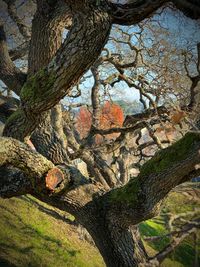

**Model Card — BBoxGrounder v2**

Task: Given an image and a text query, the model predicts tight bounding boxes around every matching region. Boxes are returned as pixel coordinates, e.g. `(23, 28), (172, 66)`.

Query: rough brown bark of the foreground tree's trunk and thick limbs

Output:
(0, 0), (200, 267)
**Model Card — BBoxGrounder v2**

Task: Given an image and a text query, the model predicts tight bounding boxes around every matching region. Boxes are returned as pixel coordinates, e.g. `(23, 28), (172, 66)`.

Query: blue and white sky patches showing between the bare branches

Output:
(0, 1), (200, 108)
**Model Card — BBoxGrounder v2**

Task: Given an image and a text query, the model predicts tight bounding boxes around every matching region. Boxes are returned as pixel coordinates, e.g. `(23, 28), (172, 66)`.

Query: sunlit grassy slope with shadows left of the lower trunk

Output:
(0, 197), (105, 267)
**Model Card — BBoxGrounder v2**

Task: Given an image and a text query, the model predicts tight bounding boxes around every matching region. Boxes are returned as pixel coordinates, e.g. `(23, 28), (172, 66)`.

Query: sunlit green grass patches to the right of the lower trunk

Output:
(139, 186), (200, 267)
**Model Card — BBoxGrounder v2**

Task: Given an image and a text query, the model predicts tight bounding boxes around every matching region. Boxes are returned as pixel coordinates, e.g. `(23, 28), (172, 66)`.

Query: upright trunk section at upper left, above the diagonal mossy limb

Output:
(28, 0), (71, 74)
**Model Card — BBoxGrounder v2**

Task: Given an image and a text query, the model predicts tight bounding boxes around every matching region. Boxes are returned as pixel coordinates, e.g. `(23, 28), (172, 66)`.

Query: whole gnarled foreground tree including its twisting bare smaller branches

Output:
(0, 0), (200, 267)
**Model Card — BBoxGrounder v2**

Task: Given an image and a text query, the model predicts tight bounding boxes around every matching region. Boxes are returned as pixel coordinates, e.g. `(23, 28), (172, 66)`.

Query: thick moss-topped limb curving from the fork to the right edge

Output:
(100, 132), (200, 226)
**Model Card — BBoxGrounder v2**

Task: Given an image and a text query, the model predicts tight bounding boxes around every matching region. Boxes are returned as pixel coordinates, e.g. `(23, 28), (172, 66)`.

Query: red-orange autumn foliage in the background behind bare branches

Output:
(76, 101), (124, 143)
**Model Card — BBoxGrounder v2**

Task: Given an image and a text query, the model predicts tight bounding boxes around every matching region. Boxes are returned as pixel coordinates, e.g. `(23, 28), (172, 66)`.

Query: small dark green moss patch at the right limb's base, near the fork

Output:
(109, 178), (140, 204)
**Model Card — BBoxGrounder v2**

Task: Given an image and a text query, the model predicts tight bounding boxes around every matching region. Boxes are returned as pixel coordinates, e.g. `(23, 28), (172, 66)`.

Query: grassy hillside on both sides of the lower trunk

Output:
(0, 184), (200, 267)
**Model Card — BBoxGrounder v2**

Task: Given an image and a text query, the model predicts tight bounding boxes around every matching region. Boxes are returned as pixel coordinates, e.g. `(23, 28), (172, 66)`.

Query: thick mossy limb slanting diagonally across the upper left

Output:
(4, 4), (111, 140)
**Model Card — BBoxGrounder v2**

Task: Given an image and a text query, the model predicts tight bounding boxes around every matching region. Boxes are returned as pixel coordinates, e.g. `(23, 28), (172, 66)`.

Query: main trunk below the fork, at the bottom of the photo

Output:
(79, 210), (147, 267)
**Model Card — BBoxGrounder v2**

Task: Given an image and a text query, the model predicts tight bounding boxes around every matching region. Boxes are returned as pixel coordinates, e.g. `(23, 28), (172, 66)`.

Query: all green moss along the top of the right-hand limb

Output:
(109, 132), (200, 205)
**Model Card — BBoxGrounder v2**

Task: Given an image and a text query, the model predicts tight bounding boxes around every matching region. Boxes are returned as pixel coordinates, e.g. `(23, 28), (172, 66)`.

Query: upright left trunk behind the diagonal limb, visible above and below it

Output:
(28, 1), (71, 164)
